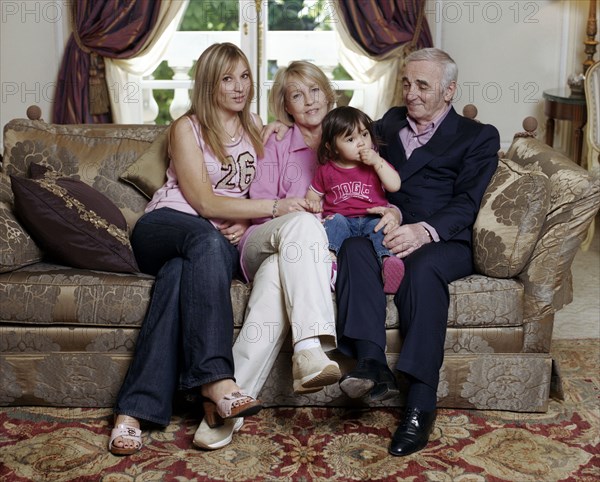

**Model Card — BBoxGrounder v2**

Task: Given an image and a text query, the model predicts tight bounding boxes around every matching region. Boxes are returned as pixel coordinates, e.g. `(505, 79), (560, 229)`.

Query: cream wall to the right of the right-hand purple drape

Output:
(427, 0), (598, 148)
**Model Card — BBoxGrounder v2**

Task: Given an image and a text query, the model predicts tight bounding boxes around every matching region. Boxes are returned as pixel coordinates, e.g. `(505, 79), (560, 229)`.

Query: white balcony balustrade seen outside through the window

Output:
(136, 31), (373, 124)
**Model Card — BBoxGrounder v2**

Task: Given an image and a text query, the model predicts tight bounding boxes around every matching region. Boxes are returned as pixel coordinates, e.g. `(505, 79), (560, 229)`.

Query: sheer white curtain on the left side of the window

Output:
(104, 0), (189, 124)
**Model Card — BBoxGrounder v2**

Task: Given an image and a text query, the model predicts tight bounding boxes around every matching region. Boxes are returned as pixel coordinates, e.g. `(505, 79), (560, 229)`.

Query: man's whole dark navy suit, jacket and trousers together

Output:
(336, 107), (500, 387)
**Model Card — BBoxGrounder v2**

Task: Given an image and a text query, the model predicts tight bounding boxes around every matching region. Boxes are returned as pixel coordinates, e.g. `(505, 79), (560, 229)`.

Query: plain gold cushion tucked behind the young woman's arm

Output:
(119, 129), (169, 199)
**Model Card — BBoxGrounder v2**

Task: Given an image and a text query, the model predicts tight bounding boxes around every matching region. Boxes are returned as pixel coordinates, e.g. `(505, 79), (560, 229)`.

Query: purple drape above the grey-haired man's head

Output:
(338, 0), (433, 58)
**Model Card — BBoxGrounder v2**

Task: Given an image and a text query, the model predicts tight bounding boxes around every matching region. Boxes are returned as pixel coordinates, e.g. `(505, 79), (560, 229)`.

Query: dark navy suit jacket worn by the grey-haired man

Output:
(375, 107), (500, 244)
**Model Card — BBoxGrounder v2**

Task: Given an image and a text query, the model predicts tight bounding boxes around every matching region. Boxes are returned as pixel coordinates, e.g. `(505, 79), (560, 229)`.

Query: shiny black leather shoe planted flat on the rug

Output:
(388, 408), (436, 457)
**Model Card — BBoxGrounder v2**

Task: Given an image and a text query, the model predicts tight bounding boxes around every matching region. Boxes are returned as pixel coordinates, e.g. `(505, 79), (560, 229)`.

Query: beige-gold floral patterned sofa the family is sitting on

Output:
(0, 109), (600, 412)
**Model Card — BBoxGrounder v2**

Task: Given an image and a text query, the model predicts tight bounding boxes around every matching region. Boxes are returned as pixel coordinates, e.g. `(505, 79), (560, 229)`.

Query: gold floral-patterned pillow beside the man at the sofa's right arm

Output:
(473, 159), (550, 278)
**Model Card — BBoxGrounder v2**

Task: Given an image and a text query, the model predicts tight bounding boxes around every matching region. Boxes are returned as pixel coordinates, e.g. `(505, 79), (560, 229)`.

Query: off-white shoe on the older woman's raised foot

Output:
(292, 346), (342, 393)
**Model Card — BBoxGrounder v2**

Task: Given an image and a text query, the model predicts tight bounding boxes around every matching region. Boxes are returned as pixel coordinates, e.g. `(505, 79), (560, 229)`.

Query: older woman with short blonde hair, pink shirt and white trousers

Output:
(194, 61), (341, 449)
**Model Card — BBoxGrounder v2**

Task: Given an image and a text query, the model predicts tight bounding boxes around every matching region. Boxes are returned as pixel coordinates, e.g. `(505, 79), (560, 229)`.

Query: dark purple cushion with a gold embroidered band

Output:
(11, 164), (139, 272)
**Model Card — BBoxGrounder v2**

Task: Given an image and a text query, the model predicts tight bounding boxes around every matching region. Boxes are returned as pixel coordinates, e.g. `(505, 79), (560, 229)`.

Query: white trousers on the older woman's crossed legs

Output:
(233, 213), (336, 397)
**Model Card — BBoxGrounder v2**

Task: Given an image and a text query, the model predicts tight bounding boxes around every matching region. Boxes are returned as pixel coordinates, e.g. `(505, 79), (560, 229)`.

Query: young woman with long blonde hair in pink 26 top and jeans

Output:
(108, 43), (306, 455)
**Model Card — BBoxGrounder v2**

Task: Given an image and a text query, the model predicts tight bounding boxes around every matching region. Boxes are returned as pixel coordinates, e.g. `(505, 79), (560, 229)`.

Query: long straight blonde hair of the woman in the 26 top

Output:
(186, 42), (263, 164)
